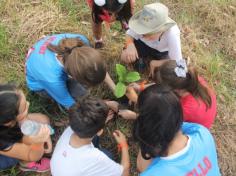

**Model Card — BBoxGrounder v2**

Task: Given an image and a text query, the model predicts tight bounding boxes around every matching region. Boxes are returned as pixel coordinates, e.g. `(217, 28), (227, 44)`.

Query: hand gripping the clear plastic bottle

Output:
(29, 124), (50, 143)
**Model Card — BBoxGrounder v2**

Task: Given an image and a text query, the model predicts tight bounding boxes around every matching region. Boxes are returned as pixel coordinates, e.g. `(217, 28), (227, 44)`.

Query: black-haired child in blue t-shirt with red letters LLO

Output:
(133, 85), (221, 176)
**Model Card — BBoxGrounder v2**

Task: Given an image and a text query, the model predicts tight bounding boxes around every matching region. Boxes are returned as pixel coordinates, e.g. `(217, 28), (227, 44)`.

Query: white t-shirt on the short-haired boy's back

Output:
(51, 127), (123, 176)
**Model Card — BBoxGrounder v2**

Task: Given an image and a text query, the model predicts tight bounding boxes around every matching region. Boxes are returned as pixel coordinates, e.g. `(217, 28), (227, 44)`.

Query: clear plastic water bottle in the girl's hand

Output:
(21, 120), (54, 136)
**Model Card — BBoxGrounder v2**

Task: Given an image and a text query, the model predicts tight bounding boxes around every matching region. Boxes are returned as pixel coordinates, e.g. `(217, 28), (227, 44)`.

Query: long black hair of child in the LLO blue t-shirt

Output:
(133, 84), (183, 159)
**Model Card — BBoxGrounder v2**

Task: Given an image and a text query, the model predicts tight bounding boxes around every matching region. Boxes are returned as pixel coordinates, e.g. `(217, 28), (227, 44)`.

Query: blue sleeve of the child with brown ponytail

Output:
(41, 81), (75, 108)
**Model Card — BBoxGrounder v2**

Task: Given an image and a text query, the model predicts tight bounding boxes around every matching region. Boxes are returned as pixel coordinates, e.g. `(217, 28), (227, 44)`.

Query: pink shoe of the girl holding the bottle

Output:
(20, 158), (50, 172)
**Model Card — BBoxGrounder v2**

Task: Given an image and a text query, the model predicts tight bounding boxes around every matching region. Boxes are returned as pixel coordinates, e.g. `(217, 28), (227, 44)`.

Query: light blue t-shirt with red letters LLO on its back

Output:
(141, 123), (220, 176)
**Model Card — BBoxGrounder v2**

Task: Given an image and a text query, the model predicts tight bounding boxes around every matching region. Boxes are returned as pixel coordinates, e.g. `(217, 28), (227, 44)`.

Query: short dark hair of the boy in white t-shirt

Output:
(69, 97), (109, 138)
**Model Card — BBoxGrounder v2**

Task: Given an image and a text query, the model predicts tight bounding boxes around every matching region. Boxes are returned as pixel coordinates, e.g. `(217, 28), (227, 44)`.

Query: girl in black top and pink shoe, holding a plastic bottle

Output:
(0, 85), (52, 172)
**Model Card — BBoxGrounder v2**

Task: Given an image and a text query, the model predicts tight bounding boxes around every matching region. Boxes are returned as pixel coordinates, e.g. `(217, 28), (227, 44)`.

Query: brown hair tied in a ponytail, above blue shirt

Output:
(48, 38), (106, 86)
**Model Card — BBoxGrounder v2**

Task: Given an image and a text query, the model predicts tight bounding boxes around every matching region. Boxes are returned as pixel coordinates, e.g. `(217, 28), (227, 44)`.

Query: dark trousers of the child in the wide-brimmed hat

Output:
(134, 40), (168, 60)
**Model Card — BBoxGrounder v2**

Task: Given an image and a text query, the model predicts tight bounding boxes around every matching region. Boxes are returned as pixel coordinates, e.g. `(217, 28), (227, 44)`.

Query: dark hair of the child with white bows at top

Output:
(92, 0), (132, 23)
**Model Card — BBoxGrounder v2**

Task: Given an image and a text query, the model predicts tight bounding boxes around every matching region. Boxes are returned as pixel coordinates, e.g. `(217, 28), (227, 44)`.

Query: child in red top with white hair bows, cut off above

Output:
(87, 0), (135, 48)
